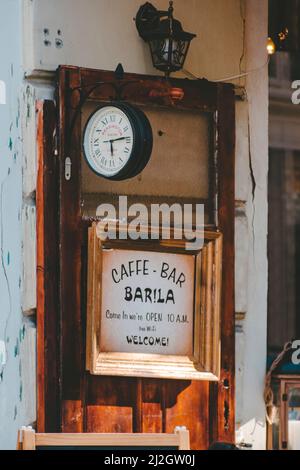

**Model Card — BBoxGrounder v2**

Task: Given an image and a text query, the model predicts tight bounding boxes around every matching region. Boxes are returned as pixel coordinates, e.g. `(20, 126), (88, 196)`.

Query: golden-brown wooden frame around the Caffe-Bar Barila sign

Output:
(86, 224), (222, 381)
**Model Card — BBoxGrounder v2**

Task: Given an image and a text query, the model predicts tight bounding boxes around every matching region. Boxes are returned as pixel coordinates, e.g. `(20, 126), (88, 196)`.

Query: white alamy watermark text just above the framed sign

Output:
(96, 196), (204, 251)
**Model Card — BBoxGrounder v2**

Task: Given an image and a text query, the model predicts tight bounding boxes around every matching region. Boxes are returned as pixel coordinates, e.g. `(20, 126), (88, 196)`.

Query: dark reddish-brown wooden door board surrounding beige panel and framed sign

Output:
(54, 67), (235, 449)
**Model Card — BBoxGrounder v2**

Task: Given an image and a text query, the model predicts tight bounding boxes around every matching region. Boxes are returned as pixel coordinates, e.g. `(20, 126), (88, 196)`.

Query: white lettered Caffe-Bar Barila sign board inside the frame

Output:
(100, 250), (195, 356)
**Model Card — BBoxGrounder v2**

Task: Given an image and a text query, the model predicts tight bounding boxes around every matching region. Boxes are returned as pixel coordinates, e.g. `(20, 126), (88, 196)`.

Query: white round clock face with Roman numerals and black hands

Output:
(83, 106), (135, 178)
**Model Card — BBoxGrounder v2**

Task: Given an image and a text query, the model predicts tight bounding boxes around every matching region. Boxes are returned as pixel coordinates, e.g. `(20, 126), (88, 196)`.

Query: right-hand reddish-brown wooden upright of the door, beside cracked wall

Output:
(210, 81), (235, 442)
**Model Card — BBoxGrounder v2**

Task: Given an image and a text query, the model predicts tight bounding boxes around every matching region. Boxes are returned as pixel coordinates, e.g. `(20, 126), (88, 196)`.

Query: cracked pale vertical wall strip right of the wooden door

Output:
(236, 0), (268, 449)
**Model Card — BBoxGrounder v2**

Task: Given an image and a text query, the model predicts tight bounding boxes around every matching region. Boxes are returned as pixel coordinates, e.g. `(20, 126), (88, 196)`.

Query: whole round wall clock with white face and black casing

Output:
(83, 103), (153, 181)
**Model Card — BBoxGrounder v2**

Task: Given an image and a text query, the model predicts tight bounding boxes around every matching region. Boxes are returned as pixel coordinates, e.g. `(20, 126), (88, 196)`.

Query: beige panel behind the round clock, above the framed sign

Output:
(82, 102), (213, 200)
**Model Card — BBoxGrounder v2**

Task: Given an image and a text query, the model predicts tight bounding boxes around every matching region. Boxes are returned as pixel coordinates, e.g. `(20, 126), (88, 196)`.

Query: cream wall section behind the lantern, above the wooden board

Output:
(25, 0), (243, 79)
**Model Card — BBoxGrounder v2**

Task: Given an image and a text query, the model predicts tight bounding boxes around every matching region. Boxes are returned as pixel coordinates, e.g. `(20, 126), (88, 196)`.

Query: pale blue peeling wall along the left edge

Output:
(0, 0), (35, 449)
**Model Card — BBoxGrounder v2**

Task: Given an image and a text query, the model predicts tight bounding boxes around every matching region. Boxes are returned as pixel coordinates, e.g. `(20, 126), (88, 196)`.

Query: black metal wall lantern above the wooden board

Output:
(135, 1), (196, 77)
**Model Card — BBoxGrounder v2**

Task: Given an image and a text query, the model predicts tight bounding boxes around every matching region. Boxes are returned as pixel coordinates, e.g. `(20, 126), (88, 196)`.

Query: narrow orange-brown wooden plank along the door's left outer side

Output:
(36, 101), (60, 432)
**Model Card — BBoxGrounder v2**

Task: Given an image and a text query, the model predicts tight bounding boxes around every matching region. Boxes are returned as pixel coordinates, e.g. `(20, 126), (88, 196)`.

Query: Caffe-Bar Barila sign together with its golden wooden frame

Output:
(87, 225), (222, 380)
